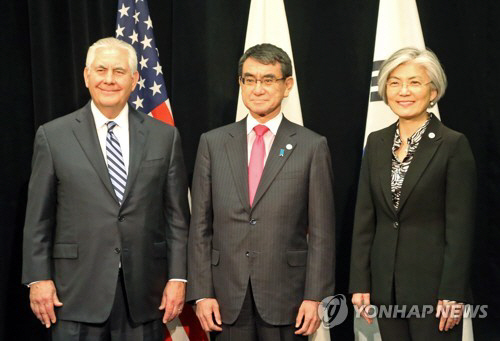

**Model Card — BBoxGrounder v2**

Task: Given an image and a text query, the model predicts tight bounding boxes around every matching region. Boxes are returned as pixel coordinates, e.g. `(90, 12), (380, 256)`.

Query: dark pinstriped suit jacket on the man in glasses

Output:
(187, 118), (335, 325)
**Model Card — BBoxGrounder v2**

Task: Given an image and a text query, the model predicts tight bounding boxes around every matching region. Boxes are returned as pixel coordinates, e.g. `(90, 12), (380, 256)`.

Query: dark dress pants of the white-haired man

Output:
(51, 269), (165, 341)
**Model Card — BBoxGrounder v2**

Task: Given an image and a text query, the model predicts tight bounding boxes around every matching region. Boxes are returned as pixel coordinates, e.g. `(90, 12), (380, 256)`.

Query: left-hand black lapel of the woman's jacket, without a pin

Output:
(376, 124), (396, 213)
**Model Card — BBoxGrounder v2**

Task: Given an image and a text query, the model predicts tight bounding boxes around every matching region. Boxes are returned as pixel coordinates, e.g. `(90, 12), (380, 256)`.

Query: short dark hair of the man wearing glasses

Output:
(238, 43), (292, 78)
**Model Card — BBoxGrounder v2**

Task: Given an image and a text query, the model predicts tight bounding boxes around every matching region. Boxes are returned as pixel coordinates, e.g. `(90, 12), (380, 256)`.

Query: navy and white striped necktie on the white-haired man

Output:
(106, 121), (127, 205)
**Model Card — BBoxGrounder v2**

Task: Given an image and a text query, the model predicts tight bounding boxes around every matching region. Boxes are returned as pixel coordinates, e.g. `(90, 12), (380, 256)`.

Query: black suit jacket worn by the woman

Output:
(350, 117), (476, 305)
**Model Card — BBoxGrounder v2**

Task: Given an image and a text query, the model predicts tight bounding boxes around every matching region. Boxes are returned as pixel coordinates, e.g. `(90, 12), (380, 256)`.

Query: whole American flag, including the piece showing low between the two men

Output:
(115, 0), (208, 341)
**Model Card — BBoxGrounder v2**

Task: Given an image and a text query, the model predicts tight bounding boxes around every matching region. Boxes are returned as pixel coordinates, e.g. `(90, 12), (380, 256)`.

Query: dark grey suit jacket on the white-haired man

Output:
(23, 103), (189, 323)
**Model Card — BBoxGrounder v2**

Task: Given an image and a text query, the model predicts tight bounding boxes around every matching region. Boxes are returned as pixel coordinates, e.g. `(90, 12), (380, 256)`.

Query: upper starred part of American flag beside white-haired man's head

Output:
(115, 0), (174, 125)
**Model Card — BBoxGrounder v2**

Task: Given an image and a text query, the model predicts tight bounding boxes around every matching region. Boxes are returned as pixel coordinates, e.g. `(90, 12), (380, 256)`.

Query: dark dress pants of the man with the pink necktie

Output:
(210, 282), (307, 341)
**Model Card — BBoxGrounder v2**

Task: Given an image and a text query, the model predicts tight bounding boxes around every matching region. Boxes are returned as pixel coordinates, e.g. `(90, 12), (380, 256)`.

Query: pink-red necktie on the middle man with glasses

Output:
(248, 124), (269, 206)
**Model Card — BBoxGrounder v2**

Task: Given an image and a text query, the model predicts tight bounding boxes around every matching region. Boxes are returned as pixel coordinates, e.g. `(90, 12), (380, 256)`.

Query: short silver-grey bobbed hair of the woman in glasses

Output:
(378, 47), (448, 104)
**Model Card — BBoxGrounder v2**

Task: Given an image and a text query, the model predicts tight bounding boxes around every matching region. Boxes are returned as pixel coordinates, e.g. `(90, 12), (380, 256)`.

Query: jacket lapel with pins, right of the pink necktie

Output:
(250, 117), (297, 208)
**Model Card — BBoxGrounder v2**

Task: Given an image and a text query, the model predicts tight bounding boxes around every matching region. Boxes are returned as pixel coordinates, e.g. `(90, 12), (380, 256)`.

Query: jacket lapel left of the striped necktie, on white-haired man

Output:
(73, 102), (118, 202)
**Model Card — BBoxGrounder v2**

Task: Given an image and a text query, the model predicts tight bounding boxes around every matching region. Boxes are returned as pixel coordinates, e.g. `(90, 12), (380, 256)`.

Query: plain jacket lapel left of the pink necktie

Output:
(226, 119), (250, 213)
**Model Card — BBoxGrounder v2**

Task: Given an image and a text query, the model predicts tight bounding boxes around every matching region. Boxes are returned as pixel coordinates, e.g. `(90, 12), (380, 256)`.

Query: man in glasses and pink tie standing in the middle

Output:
(187, 44), (335, 341)
